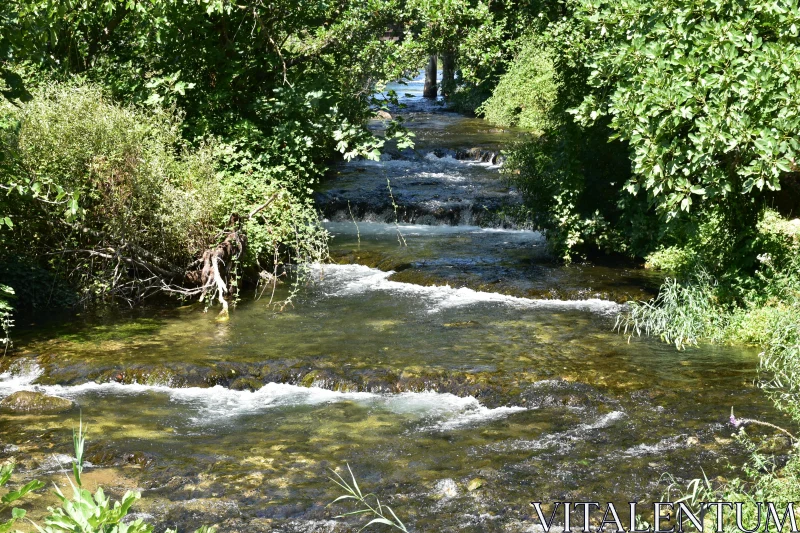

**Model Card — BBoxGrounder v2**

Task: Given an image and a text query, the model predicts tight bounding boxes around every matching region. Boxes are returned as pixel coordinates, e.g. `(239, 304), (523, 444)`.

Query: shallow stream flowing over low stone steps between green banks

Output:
(0, 77), (779, 531)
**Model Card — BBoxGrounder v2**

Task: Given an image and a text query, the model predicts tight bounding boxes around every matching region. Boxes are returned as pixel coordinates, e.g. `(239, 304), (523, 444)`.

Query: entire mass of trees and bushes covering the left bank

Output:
(0, 0), (419, 340)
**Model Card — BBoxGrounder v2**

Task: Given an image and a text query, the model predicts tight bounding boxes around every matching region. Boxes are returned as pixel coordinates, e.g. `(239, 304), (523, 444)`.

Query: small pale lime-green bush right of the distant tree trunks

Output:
(476, 40), (560, 134)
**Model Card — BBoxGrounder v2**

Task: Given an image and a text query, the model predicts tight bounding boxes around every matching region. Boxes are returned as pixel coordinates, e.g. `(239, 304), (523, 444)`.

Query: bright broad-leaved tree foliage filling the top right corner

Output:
(576, 0), (800, 224)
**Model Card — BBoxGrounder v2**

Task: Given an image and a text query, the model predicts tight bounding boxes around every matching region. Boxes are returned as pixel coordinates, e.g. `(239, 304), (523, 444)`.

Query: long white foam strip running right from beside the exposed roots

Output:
(313, 264), (623, 315)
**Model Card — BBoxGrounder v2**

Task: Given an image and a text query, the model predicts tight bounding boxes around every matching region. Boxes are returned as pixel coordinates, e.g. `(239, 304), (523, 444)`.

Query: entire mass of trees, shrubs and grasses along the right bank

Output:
(454, 0), (800, 520)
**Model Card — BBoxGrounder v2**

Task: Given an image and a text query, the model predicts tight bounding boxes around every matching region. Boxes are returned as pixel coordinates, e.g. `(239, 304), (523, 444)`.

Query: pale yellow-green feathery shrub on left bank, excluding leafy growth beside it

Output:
(2, 79), (220, 247)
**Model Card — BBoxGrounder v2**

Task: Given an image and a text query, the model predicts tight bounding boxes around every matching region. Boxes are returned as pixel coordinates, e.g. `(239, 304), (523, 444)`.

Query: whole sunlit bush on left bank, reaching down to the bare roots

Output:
(0, 81), (327, 316)
